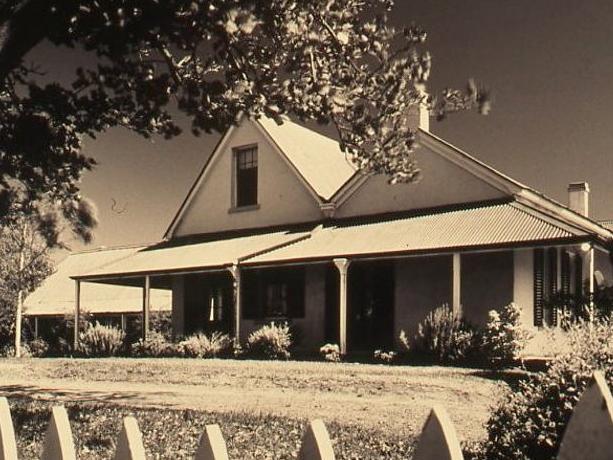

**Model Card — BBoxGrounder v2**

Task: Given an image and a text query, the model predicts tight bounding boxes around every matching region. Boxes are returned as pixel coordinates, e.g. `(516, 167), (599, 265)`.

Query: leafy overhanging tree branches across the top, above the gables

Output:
(0, 0), (488, 235)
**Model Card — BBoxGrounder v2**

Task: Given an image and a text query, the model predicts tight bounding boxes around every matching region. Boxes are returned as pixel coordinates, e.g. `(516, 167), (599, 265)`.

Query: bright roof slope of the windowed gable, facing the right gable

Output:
(258, 117), (356, 200)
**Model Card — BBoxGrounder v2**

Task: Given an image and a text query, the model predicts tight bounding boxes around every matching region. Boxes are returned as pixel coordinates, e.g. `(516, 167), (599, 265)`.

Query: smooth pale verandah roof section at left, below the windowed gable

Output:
(75, 231), (309, 279)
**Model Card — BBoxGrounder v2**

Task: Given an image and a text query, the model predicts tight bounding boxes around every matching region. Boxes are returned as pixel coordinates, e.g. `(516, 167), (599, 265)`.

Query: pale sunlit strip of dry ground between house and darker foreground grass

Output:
(0, 358), (508, 440)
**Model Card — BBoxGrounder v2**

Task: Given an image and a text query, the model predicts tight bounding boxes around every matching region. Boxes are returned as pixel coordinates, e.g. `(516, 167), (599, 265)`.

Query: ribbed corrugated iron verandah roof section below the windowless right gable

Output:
(244, 203), (588, 265)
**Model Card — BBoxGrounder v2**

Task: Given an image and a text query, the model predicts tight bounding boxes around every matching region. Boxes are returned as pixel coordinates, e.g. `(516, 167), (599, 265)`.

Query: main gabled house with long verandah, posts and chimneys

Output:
(68, 109), (613, 352)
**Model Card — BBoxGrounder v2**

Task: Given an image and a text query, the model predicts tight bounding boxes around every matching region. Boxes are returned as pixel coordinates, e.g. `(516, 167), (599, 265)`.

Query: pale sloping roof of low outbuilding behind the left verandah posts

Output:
(24, 247), (171, 316)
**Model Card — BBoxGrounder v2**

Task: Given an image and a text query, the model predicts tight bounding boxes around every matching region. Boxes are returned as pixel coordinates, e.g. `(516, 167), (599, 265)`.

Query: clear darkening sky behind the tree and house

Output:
(30, 0), (613, 253)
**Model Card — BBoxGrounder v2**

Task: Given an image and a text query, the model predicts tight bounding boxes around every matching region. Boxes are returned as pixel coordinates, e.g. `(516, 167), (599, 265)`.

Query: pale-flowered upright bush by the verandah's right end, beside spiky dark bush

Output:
(481, 303), (529, 368)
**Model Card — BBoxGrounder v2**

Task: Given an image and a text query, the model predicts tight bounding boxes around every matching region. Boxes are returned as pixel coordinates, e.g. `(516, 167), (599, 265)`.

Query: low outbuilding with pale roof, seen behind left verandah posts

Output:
(23, 246), (171, 337)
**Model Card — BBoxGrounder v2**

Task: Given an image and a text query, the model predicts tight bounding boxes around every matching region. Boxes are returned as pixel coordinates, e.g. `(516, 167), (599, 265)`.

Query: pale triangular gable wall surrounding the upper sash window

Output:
(174, 120), (321, 236)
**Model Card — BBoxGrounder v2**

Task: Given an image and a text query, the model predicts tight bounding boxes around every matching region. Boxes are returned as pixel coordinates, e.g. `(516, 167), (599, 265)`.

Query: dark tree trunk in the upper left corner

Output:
(0, 0), (51, 83)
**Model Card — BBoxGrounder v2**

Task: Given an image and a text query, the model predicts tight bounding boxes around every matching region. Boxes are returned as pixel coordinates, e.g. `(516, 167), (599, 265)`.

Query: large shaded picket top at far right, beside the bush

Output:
(558, 372), (613, 460)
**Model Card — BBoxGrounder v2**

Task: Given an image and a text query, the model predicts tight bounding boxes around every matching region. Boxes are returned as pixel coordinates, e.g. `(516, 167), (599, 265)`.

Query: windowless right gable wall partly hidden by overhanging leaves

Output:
(335, 147), (505, 217)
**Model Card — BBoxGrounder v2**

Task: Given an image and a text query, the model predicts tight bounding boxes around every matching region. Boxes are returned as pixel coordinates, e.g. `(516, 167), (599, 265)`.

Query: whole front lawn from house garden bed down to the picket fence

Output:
(0, 358), (508, 459)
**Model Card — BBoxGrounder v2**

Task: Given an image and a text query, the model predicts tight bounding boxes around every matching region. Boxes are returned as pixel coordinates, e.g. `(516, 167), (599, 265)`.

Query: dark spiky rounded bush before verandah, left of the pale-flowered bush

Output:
(412, 305), (476, 363)
